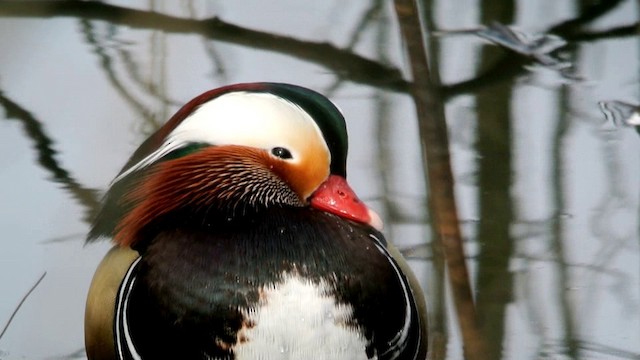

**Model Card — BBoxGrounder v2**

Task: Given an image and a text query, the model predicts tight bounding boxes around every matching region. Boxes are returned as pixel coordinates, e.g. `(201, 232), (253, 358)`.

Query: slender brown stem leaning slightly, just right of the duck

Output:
(395, 0), (487, 360)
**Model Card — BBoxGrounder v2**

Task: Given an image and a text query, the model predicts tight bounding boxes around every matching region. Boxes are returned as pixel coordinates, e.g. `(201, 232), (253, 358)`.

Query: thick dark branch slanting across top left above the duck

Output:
(0, 0), (408, 92)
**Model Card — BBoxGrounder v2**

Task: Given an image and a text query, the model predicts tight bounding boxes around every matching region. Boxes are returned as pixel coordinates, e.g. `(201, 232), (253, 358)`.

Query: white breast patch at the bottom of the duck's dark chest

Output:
(233, 275), (367, 360)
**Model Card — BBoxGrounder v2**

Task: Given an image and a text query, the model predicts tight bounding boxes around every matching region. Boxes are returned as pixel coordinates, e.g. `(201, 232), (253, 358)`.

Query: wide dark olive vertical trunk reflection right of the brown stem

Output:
(475, 1), (516, 359)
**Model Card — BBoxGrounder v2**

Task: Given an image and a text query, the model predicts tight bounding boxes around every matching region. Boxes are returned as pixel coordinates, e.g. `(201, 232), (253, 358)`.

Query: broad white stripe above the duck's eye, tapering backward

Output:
(113, 92), (329, 183)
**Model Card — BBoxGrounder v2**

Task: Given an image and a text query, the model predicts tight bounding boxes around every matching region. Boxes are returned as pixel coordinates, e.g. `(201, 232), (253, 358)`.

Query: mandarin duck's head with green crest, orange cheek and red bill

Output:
(89, 83), (382, 246)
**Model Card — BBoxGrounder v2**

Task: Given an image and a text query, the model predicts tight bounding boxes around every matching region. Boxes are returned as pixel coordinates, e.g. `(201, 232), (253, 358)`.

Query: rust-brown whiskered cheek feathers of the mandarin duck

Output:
(115, 145), (304, 246)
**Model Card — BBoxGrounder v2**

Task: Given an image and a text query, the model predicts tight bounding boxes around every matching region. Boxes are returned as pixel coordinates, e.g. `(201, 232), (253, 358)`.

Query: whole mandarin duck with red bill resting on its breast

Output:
(85, 83), (427, 360)
